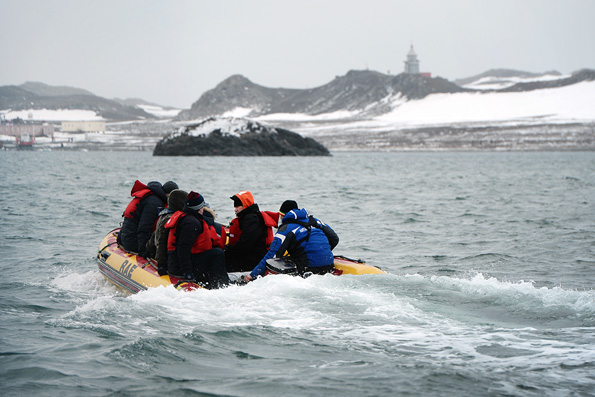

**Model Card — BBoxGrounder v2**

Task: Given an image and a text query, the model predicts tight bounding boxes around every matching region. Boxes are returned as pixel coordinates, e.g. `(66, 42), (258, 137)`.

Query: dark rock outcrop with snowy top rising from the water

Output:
(153, 117), (330, 156)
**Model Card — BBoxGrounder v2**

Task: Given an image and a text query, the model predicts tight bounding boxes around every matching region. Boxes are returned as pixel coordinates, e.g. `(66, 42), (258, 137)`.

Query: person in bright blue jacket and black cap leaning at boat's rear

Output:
(244, 200), (339, 281)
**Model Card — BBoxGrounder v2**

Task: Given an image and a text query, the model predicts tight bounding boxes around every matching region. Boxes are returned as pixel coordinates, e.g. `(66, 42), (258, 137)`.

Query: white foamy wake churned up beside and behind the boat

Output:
(50, 256), (595, 392)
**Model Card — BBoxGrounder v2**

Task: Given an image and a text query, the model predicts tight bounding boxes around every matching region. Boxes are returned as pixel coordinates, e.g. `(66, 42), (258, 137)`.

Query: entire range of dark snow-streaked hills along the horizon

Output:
(5, 69), (595, 122)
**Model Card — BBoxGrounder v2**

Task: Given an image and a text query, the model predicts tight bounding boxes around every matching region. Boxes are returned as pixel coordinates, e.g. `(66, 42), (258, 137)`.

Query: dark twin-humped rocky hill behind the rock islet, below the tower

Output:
(178, 70), (465, 120)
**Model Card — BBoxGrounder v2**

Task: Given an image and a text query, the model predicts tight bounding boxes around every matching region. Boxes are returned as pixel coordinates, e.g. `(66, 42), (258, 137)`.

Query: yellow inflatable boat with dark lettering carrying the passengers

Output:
(97, 228), (385, 293)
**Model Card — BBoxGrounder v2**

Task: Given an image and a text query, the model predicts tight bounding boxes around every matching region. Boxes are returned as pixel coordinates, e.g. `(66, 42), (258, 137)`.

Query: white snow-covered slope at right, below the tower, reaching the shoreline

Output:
(251, 79), (595, 150)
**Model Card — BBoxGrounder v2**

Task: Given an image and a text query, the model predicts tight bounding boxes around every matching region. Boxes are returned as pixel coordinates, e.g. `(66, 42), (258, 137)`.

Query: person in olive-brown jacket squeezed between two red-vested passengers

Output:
(147, 187), (188, 276)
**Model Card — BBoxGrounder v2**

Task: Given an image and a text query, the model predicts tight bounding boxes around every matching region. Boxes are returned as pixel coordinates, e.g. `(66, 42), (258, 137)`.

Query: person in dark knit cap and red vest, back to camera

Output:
(165, 191), (229, 288)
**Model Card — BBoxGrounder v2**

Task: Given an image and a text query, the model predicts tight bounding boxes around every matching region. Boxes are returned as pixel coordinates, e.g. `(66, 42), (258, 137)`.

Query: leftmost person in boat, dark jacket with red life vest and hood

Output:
(118, 180), (178, 257)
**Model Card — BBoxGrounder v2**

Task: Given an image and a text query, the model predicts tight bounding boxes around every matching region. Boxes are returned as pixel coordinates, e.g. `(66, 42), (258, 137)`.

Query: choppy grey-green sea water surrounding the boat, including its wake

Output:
(0, 152), (595, 396)
